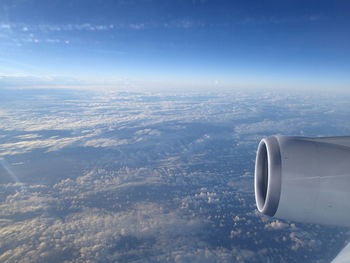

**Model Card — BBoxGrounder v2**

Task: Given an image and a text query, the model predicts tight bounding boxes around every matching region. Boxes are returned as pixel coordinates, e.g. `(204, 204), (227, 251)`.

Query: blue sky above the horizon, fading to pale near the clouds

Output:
(0, 0), (350, 90)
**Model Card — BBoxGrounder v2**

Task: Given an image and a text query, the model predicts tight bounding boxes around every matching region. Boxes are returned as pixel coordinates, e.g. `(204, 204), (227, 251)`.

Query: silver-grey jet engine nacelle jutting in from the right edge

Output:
(254, 136), (350, 227)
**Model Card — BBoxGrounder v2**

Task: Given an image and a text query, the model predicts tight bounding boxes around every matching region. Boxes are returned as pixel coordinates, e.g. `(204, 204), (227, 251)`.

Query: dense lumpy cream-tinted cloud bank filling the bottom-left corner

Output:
(0, 203), (208, 262)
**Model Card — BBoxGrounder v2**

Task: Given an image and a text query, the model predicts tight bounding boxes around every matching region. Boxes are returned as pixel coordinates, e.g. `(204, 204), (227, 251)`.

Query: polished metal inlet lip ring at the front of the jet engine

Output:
(254, 136), (281, 216)
